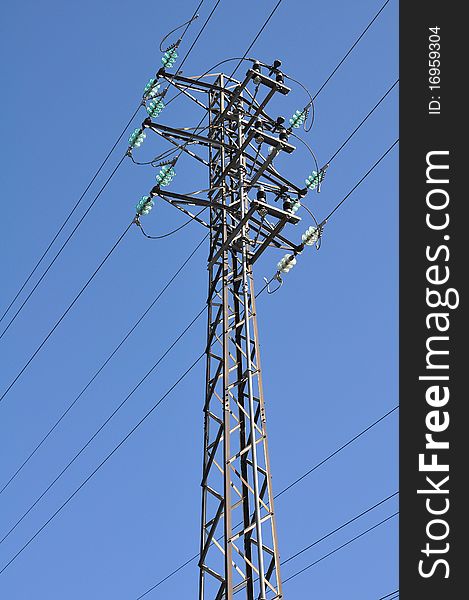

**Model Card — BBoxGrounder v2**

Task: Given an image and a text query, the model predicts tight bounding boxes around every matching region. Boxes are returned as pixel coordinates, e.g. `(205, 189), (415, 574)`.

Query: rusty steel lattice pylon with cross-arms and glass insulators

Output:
(136, 61), (321, 600)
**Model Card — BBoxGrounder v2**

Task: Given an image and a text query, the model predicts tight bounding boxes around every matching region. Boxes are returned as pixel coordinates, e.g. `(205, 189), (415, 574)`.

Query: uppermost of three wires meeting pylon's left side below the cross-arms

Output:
(0, 234), (209, 494)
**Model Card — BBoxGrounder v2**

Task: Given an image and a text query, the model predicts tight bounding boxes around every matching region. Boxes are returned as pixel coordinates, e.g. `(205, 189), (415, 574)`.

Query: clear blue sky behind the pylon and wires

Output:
(0, 0), (398, 600)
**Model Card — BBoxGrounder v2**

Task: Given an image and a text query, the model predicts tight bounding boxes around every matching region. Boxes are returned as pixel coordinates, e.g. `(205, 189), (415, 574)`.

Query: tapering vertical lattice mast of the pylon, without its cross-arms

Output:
(199, 76), (282, 600)
